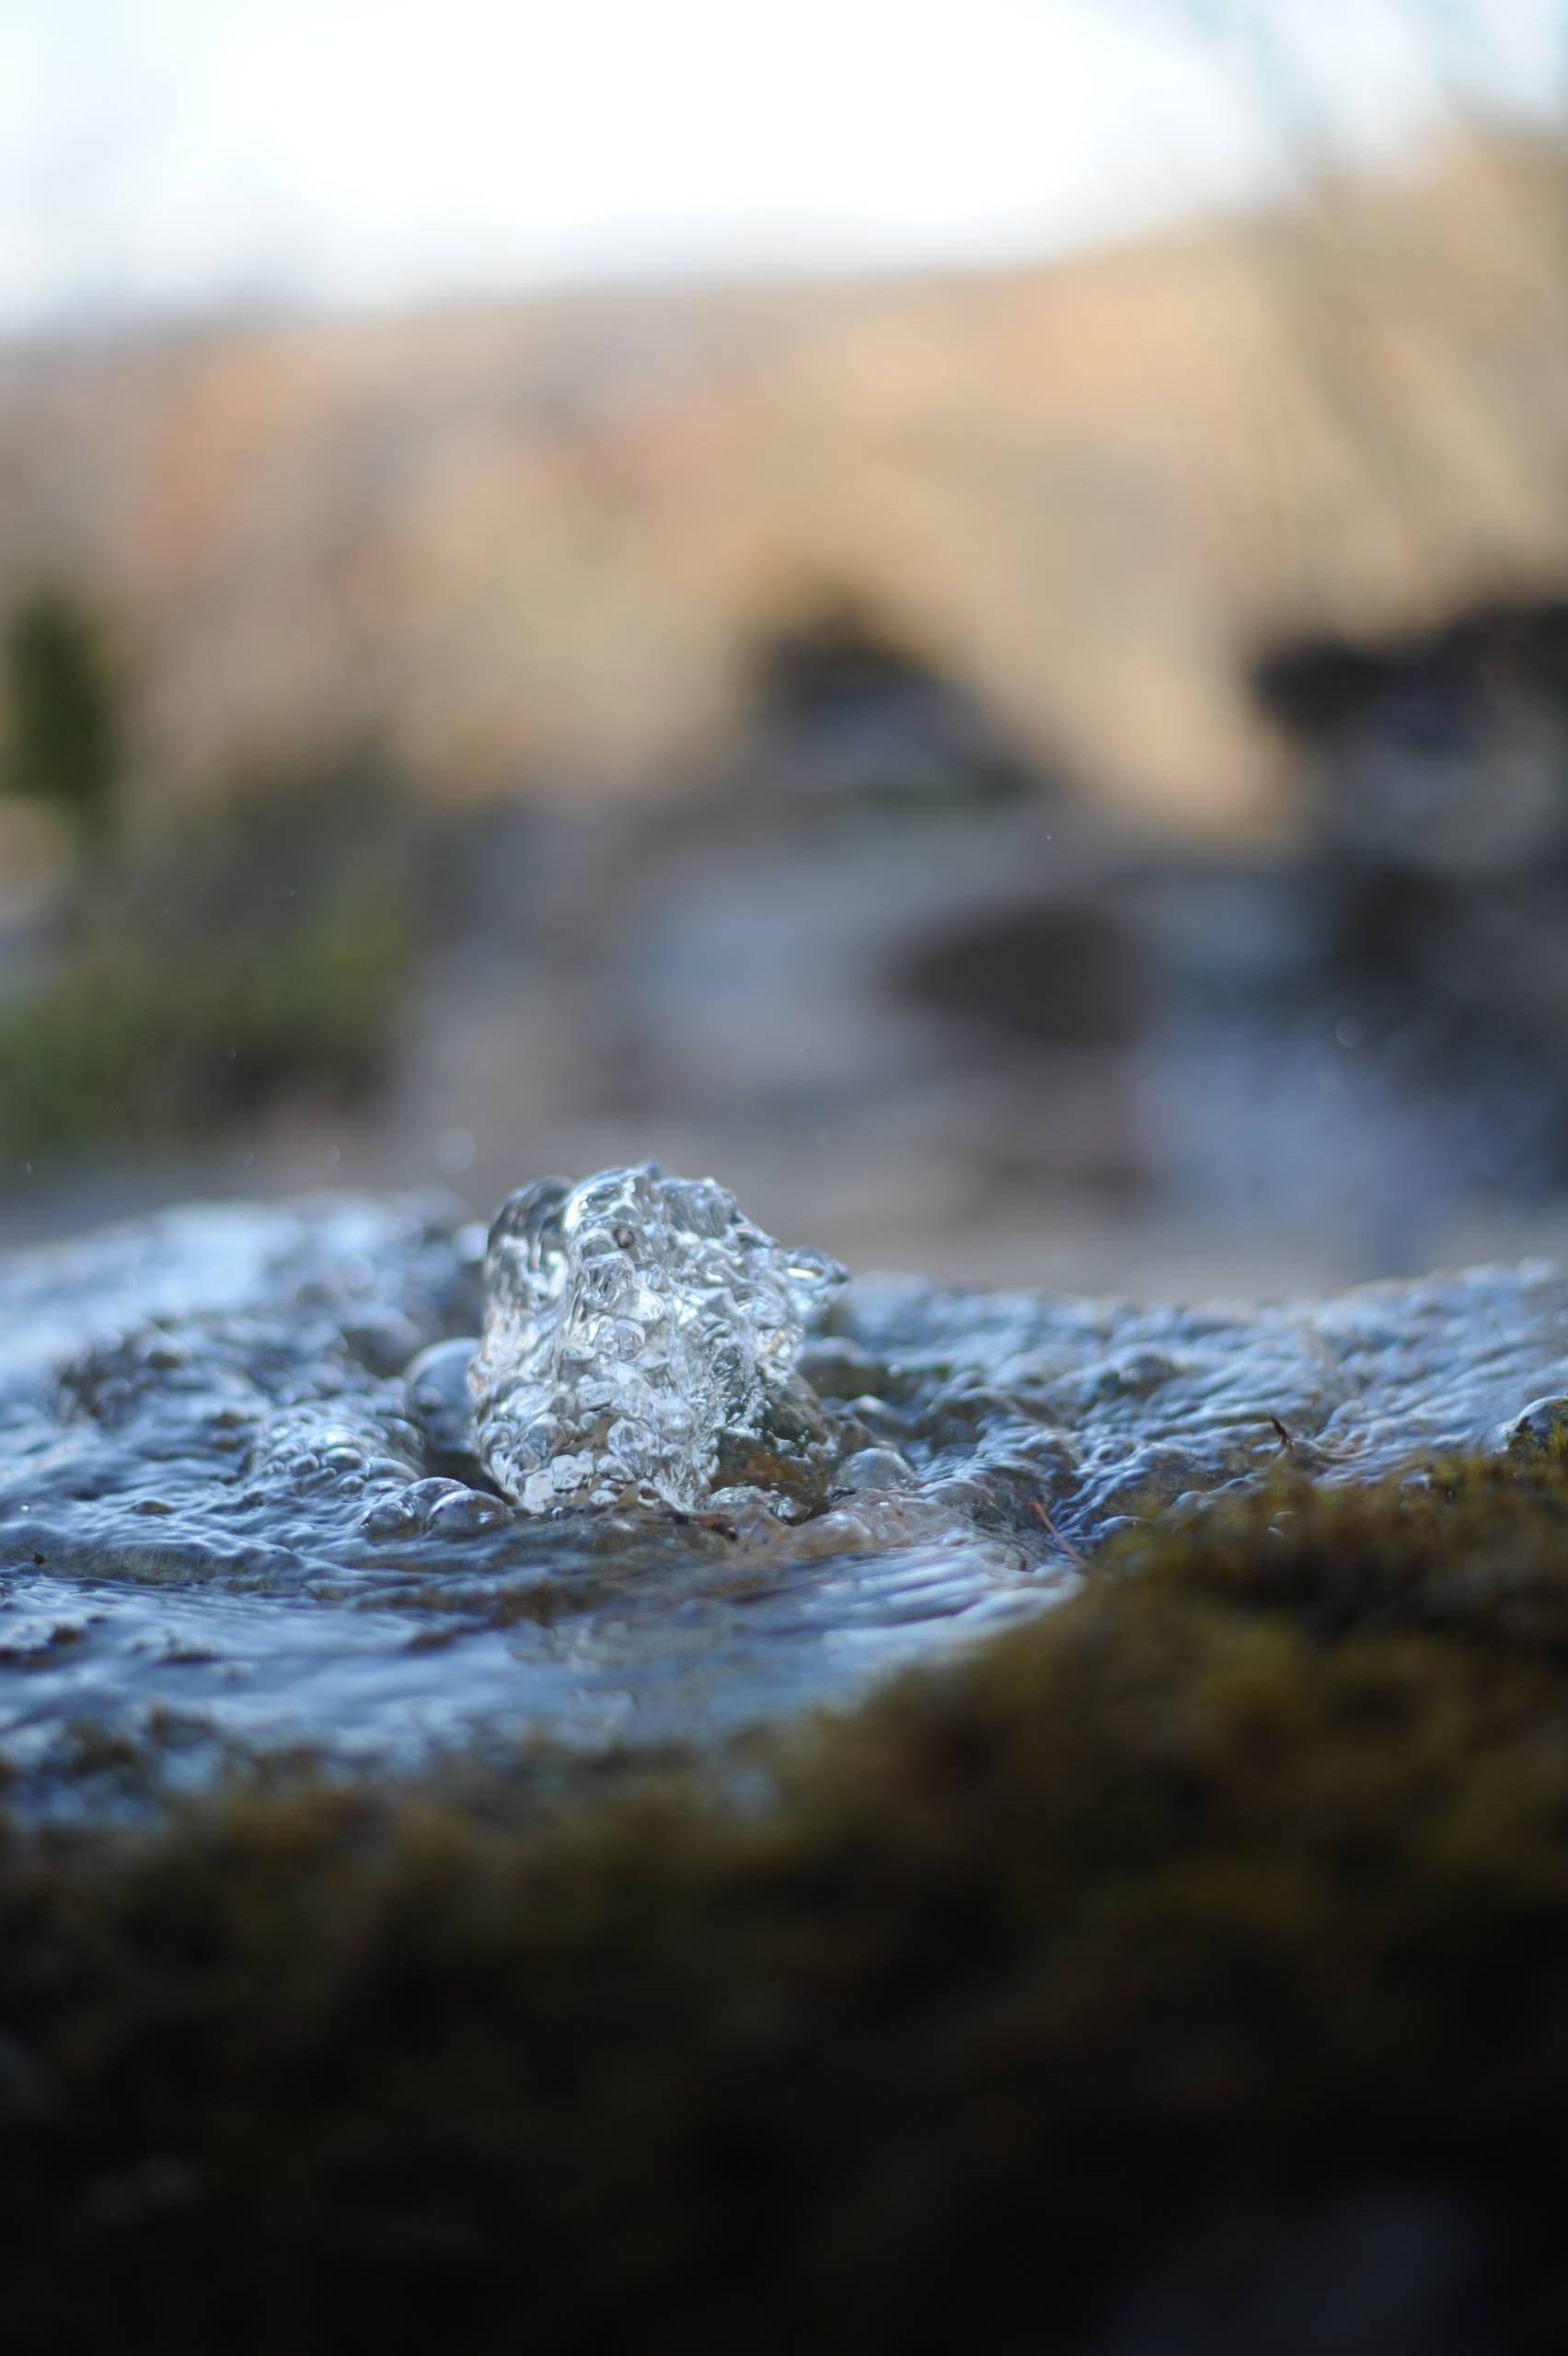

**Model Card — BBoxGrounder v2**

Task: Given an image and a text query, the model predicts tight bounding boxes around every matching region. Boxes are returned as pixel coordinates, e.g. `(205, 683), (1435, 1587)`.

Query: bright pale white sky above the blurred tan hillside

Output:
(0, 0), (1568, 329)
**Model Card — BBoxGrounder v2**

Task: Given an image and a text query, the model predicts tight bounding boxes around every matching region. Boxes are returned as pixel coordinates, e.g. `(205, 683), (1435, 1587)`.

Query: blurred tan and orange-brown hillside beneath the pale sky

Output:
(0, 134), (1568, 829)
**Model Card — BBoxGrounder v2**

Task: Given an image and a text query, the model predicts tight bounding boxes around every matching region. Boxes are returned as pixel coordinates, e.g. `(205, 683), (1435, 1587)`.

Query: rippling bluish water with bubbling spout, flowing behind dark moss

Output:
(0, 1166), (1568, 1809)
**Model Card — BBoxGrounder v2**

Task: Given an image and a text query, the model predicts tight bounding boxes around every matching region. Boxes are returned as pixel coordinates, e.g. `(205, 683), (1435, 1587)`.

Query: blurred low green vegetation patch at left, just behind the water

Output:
(0, 766), (417, 1160)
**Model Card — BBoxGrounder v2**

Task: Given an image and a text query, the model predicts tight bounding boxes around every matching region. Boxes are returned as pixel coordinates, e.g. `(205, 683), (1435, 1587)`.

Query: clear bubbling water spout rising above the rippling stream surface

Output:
(468, 1161), (846, 1515)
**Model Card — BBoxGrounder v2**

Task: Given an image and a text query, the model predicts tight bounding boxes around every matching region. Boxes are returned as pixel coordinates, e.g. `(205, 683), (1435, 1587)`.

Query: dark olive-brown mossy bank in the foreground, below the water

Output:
(15, 1461), (1568, 2356)
